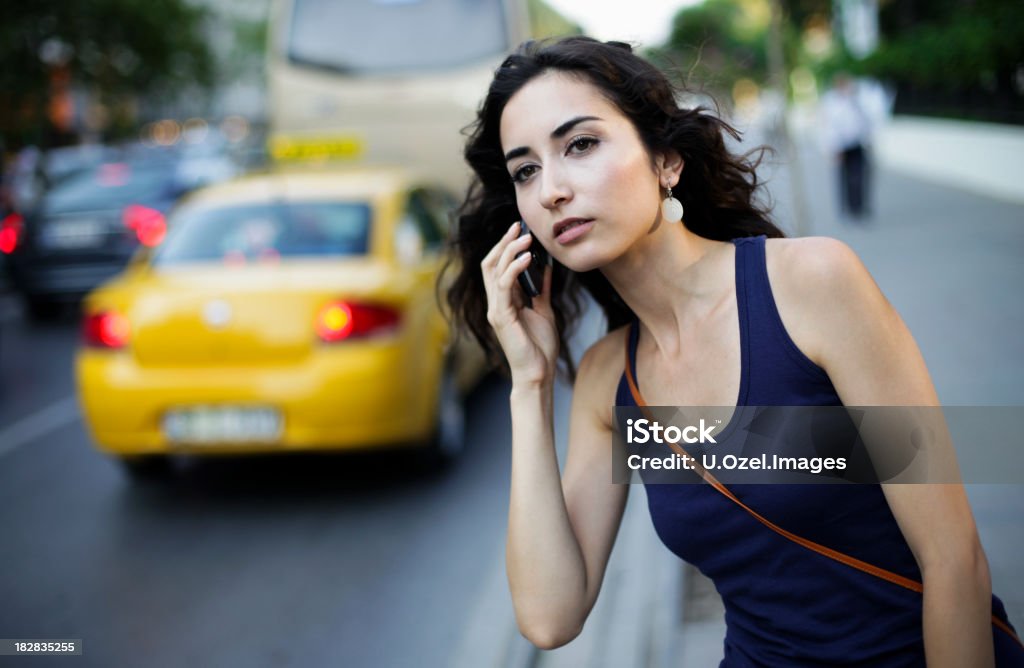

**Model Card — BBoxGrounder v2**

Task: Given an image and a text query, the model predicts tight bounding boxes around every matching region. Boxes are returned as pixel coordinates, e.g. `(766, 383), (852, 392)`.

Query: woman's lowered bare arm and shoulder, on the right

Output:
(768, 238), (994, 667)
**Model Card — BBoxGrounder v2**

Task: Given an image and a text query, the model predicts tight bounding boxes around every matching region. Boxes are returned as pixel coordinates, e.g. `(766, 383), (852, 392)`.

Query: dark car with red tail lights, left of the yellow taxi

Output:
(4, 157), (198, 319)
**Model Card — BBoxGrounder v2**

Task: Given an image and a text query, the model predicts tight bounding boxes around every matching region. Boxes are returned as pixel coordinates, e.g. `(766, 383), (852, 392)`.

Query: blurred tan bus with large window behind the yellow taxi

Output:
(268, 0), (550, 192)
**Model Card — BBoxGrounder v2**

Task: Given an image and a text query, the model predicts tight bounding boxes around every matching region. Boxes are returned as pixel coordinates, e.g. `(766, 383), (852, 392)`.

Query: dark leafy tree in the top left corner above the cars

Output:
(0, 0), (214, 149)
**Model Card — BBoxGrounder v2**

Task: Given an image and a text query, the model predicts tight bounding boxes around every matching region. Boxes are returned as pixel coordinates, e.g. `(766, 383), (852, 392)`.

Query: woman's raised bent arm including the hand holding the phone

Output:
(480, 225), (628, 649)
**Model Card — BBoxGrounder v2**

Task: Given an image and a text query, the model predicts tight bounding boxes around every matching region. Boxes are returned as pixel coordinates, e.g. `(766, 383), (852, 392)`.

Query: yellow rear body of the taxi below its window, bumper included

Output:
(79, 258), (444, 454)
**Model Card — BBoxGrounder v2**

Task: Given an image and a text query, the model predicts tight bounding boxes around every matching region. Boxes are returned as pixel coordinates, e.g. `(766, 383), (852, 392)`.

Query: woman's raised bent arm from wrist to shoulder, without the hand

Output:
(506, 332), (629, 649)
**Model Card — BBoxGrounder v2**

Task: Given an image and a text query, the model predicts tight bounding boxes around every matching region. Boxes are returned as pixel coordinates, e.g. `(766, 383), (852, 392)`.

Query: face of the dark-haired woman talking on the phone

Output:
(500, 71), (681, 272)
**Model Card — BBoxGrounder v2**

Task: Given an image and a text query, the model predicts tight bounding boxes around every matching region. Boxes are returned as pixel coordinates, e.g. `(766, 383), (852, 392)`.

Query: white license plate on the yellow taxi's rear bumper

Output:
(161, 407), (284, 445)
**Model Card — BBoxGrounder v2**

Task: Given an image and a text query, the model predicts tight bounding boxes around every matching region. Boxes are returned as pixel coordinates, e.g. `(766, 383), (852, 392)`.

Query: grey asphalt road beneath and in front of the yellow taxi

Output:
(0, 296), (593, 666)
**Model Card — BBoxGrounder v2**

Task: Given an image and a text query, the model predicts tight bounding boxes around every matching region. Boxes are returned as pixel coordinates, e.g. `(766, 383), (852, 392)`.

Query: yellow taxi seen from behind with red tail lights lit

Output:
(76, 169), (483, 473)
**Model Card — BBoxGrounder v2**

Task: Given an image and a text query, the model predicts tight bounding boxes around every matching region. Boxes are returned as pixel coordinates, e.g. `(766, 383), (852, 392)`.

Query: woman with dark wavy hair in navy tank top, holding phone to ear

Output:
(449, 38), (1024, 666)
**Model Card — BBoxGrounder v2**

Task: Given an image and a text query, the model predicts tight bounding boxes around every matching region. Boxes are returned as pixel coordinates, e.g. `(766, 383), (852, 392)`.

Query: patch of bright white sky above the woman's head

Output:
(546, 0), (700, 46)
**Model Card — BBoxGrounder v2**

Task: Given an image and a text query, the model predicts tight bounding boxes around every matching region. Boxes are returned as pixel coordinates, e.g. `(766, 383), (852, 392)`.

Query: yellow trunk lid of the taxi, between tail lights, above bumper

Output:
(126, 260), (406, 367)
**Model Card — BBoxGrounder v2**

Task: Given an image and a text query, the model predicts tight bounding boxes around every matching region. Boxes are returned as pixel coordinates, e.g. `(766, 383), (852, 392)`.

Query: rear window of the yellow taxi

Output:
(154, 202), (371, 265)
